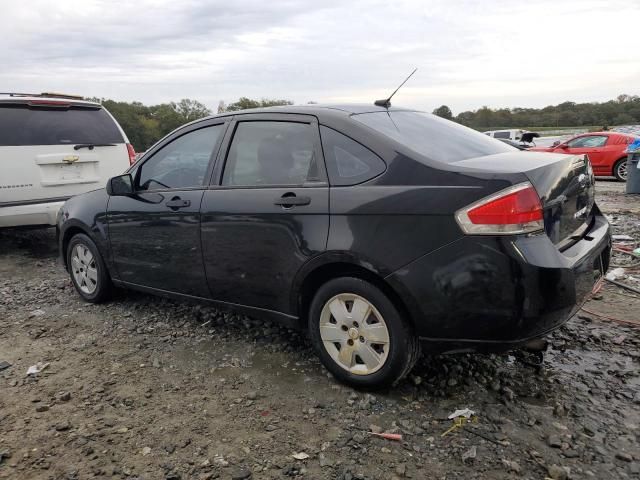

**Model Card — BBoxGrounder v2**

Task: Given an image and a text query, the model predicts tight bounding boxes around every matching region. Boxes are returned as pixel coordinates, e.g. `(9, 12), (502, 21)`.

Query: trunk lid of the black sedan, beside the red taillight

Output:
(456, 151), (595, 249)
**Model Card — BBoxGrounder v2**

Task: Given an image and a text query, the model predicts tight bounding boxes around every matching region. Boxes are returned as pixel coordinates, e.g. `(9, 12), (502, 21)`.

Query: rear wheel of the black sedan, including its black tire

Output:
(309, 277), (420, 389)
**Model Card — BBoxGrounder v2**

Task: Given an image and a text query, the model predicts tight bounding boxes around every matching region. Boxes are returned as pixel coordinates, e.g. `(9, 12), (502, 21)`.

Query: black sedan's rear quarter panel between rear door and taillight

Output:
(321, 119), (526, 275)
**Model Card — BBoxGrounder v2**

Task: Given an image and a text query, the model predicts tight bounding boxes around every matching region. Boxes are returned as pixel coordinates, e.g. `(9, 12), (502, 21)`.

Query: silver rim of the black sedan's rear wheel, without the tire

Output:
(320, 293), (390, 375)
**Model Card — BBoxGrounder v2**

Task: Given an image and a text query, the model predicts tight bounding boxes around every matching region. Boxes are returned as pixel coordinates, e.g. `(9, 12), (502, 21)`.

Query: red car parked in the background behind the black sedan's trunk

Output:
(529, 132), (634, 182)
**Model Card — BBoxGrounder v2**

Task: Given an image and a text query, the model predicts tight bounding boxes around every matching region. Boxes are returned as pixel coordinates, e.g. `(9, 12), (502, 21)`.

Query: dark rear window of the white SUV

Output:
(0, 105), (123, 146)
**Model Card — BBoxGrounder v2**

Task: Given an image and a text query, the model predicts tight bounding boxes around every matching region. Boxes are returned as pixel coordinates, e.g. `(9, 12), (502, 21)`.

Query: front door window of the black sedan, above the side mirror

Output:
(138, 125), (223, 190)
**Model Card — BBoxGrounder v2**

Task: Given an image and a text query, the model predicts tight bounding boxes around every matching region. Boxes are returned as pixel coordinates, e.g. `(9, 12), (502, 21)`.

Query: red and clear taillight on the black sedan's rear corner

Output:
(456, 182), (544, 235)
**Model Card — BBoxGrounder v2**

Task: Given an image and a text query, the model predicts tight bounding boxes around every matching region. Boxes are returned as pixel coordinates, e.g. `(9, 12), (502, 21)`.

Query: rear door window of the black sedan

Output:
(222, 122), (320, 186)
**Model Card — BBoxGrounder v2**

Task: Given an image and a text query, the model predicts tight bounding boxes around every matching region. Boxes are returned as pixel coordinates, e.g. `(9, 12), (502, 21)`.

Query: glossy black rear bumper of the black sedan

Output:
(387, 212), (611, 351)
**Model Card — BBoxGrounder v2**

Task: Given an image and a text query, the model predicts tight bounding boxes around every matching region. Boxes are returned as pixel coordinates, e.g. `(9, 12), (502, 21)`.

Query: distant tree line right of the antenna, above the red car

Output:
(433, 94), (640, 130)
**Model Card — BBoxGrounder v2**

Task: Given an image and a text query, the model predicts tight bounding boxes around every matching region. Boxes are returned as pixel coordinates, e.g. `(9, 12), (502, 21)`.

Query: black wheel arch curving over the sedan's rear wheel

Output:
(292, 257), (415, 329)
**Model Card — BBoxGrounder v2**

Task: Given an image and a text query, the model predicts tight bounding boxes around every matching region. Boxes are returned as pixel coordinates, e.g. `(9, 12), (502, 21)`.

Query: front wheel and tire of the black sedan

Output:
(67, 233), (113, 303)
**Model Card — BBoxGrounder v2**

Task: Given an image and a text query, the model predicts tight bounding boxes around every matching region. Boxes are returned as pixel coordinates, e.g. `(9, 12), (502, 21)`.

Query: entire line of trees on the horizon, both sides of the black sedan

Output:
(89, 94), (640, 148)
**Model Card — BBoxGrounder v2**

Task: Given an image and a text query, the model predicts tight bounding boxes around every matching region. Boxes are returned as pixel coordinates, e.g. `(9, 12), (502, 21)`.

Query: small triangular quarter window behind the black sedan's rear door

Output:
(320, 126), (386, 185)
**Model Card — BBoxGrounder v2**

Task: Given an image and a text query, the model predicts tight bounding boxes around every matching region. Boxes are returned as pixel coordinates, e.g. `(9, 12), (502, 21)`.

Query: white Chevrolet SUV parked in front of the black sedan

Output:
(0, 93), (135, 228)
